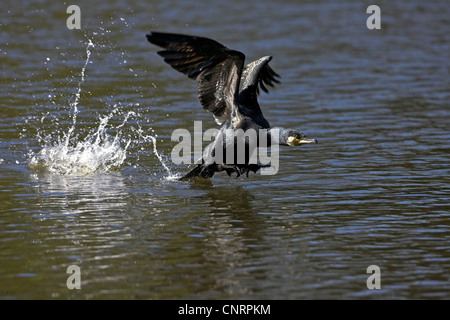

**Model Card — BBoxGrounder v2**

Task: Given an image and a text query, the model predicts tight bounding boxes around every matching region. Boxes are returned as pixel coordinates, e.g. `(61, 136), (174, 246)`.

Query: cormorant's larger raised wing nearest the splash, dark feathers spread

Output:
(147, 32), (244, 124)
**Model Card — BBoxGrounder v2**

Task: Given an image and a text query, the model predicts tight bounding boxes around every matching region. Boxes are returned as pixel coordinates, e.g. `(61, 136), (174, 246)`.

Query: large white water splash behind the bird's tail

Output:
(28, 39), (175, 180)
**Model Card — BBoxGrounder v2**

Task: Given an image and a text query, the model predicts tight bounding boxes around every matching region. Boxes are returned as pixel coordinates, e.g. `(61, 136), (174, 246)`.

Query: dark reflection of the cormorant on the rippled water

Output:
(187, 179), (268, 295)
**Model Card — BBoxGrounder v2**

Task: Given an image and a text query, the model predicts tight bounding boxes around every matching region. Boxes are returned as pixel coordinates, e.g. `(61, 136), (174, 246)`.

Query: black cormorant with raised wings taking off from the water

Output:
(147, 32), (317, 180)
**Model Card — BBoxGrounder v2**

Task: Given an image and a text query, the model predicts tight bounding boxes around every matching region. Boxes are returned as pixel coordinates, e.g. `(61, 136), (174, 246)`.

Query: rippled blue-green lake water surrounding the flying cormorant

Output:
(0, 0), (450, 299)
